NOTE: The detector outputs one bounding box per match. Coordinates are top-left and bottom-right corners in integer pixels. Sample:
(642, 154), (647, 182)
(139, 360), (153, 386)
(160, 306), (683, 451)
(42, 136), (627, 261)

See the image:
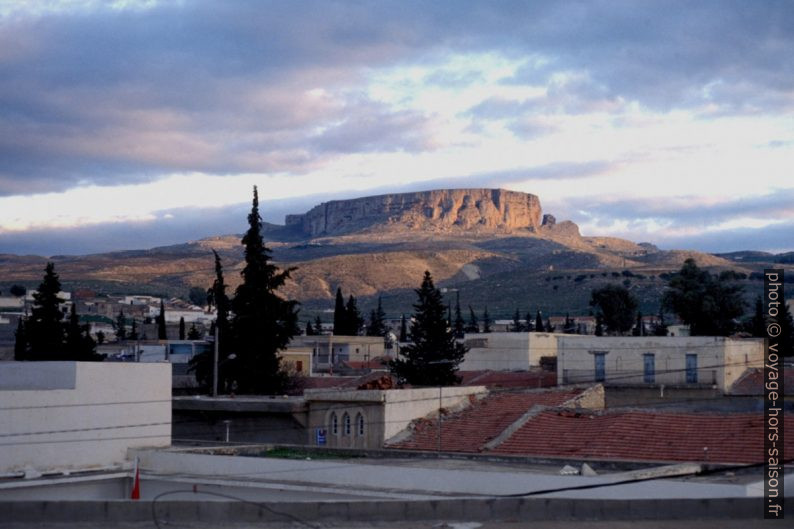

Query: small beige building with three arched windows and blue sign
(304, 386), (487, 448)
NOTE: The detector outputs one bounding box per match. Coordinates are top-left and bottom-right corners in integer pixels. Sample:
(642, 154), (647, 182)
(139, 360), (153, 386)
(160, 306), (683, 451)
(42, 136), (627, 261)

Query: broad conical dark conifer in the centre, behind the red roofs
(389, 272), (467, 386)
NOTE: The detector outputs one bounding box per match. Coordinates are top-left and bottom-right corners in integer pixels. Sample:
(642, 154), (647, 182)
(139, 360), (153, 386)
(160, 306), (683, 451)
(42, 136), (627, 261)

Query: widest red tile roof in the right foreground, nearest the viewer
(488, 410), (794, 463)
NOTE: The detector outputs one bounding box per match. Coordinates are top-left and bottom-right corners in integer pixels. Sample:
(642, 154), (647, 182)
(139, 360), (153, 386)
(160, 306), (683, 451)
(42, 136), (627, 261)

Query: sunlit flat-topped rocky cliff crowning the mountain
(286, 189), (541, 237)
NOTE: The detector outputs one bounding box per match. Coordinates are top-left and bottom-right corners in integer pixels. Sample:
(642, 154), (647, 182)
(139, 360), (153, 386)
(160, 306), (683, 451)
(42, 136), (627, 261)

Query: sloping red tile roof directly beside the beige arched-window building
(390, 389), (583, 452)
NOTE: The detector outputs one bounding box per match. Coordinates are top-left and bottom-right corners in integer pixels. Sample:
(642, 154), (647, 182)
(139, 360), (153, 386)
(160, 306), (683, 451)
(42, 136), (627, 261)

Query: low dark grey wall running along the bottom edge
(0, 498), (794, 524)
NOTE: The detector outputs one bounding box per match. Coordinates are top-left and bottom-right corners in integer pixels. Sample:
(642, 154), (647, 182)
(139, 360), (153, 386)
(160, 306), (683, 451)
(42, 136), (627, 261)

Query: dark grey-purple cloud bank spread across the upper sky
(0, 1), (794, 196)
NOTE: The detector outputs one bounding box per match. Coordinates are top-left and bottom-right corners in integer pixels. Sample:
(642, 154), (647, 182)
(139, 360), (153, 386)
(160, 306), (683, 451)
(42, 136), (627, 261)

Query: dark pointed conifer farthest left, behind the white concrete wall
(26, 263), (65, 360)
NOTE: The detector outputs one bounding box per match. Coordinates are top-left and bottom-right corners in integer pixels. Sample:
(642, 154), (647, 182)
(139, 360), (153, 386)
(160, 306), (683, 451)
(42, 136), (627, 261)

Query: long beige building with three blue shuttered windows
(557, 335), (764, 391)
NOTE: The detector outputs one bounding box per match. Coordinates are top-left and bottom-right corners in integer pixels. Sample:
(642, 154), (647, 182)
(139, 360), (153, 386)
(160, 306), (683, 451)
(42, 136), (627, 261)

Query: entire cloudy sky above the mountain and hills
(0, 0), (794, 255)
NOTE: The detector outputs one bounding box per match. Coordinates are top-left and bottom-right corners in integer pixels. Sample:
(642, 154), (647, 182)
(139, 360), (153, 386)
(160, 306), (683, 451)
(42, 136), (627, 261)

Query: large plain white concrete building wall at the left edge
(0, 362), (171, 473)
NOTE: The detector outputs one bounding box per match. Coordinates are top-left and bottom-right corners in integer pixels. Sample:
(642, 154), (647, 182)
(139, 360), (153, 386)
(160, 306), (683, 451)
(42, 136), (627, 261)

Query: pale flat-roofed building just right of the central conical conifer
(460, 332), (559, 371)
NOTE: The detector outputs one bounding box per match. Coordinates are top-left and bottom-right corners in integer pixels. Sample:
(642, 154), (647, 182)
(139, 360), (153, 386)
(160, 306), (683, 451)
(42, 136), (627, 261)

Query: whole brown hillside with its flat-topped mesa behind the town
(0, 189), (790, 318)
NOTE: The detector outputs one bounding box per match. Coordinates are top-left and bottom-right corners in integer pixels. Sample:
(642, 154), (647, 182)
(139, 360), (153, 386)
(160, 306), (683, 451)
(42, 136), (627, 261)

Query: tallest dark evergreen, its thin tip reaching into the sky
(232, 187), (300, 394)
